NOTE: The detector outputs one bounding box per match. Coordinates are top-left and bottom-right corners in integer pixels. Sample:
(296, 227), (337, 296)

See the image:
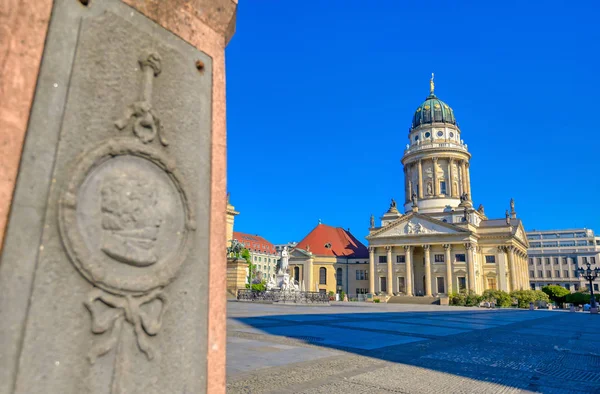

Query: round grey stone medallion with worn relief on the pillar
(59, 139), (195, 295)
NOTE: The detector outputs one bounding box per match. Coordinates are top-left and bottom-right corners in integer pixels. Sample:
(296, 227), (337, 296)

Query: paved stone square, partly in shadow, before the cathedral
(227, 301), (600, 394)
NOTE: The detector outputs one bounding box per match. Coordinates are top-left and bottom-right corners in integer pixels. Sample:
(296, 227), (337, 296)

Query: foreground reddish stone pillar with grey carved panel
(0, 0), (237, 394)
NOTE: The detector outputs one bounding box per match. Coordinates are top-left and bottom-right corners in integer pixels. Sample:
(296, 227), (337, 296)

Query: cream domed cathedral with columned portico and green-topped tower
(367, 74), (529, 302)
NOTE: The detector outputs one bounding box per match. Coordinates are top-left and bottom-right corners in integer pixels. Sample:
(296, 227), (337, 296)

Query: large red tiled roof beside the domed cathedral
(296, 224), (369, 259)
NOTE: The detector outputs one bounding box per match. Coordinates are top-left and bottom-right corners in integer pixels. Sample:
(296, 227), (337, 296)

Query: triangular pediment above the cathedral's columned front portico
(367, 213), (469, 240)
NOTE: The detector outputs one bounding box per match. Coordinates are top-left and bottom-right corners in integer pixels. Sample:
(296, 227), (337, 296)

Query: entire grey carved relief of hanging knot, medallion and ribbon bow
(59, 52), (196, 386)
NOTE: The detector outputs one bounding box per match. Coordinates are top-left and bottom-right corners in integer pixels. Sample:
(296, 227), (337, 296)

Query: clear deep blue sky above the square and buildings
(226, 0), (600, 243)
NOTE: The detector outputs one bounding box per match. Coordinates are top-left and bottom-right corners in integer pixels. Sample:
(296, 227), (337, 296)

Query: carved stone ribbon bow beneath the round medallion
(84, 289), (167, 364)
